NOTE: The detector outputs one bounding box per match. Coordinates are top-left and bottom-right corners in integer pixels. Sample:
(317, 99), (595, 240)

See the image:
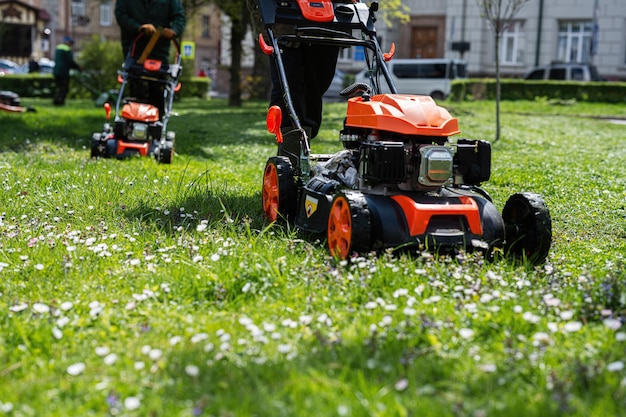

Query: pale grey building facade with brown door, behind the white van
(385, 0), (626, 80)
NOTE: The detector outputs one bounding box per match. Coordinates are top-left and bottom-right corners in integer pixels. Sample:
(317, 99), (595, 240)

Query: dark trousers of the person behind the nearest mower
(270, 44), (339, 137)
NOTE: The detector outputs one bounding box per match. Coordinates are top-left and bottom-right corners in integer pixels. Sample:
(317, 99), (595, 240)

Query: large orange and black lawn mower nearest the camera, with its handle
(258, 0), (552, 264)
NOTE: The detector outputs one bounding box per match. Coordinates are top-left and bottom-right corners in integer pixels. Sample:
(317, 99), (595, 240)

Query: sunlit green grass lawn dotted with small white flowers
(0, 99), (626, 417)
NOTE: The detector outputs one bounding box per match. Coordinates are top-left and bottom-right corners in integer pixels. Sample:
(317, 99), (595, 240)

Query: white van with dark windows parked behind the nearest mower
(356, 58), (467, 100)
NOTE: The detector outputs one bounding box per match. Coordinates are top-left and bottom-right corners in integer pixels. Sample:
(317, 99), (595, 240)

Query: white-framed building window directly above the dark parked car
(557, 20), (593, 62)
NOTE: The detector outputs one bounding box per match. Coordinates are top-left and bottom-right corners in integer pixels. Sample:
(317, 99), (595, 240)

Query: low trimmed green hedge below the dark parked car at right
(450, 78), (626, 103)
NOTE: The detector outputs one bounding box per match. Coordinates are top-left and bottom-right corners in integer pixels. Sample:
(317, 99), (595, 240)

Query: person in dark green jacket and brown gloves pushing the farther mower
(115, 0), (187, 117)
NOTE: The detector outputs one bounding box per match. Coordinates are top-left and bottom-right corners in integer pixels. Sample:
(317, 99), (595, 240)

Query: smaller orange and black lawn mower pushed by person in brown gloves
(91, 31), (183, 164)
